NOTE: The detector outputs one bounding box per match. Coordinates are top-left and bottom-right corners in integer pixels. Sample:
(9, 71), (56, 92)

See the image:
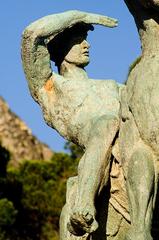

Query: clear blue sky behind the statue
(0, 0), (140, 151)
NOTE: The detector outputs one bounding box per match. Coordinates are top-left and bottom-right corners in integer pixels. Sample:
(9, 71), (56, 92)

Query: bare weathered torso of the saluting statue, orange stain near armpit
(40, 74), (120, 145)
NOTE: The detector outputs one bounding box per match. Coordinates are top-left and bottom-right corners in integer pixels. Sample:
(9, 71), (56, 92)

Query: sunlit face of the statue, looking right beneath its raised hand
(64, 36), (90, 67)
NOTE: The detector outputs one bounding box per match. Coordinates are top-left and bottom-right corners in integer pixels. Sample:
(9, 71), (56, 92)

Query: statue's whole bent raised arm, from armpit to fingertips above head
(22, 11), (117, 101)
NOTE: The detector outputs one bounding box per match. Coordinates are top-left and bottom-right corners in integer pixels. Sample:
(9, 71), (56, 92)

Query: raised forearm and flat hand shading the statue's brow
(25, 10), (117, 38)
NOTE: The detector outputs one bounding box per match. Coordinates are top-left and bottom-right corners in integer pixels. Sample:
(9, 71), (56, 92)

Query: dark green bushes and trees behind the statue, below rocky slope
(0, 143), (82, 240)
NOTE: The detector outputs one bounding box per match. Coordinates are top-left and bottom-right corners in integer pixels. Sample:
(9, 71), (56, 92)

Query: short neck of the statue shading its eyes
(60, 61), (88, 80)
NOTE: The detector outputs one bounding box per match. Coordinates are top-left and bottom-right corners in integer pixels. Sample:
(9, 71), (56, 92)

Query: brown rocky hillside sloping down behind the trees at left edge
(0, 97), (53, 166)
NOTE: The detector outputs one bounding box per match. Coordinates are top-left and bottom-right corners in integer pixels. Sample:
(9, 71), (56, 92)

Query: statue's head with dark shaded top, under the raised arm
(48, 23), (94, 71)
